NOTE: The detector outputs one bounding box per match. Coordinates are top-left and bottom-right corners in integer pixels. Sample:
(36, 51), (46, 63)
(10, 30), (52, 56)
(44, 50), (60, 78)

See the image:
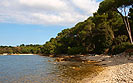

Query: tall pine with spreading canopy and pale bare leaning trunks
(98, 0), (133, 44)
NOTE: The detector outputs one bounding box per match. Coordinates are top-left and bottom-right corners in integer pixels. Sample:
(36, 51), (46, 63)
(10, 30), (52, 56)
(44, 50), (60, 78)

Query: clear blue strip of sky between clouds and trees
(0, 23), (66, 46)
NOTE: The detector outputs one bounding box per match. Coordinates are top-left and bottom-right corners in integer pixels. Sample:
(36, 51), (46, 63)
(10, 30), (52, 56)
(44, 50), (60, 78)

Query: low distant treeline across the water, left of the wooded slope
(0, 44), (42, 54)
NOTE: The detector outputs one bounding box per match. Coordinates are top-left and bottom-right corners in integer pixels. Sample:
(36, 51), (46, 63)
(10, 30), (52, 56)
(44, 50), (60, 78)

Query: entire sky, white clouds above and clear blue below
(0, 0), (102, 46)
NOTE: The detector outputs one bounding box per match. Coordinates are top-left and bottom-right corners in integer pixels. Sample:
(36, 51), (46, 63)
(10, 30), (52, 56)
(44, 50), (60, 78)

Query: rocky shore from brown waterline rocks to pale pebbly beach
(48, 53), (133, 83)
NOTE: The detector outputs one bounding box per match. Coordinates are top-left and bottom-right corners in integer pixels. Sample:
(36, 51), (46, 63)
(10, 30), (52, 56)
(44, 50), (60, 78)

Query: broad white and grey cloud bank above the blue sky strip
(0, 0), (99, 25)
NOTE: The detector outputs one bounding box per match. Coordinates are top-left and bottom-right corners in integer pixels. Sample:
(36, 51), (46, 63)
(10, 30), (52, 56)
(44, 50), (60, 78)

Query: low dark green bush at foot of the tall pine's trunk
(112, 42), (133, 54)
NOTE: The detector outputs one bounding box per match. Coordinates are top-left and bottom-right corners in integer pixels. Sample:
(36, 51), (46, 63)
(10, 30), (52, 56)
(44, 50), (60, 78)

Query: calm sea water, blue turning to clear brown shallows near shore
(0, 55), (102, 83)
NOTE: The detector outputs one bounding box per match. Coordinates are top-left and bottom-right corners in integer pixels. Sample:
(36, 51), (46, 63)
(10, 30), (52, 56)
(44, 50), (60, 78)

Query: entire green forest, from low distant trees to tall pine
(0, 0), (133, 54)
